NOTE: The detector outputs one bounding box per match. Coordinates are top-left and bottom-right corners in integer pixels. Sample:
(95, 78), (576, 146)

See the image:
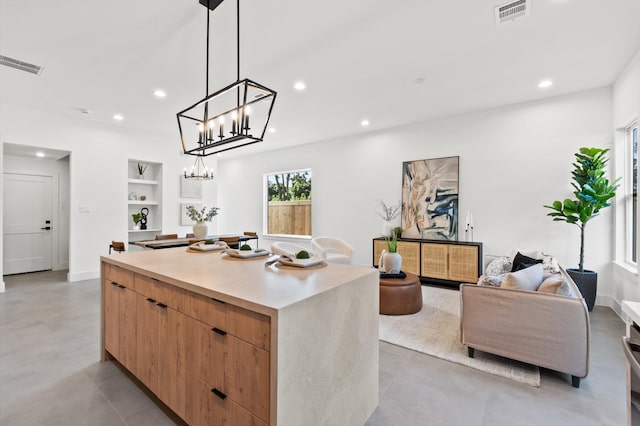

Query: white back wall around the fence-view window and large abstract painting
(218, 88), (614, 295)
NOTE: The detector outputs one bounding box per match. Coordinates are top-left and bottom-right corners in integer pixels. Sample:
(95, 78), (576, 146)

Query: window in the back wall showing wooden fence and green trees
(264, 169), (311, 237)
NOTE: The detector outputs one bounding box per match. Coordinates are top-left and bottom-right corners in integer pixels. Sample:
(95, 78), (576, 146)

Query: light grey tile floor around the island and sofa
(0, 271), (626, 426)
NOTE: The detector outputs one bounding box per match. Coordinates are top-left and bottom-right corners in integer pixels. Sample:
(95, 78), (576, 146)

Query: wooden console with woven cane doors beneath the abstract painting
(373, 237), (482, 284)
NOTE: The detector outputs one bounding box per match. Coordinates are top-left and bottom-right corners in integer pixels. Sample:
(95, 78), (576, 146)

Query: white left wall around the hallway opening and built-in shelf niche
(0, 103), (216, 281)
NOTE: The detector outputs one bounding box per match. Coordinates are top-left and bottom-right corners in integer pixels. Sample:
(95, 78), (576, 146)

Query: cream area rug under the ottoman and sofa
(379, 286), (540, 386)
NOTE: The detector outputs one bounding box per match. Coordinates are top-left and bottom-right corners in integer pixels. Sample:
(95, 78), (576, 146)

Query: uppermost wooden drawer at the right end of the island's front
(178, 291), (271, 350)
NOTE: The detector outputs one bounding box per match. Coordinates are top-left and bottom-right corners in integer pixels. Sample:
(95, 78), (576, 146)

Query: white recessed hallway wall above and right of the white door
(3, 155), (69, 270)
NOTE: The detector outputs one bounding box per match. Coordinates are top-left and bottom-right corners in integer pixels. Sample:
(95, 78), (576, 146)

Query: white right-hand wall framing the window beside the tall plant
(612, 51), (640, 314)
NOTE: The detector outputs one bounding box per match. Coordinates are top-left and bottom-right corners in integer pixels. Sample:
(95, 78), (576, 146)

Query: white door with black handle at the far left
(2, 173), (53, 275)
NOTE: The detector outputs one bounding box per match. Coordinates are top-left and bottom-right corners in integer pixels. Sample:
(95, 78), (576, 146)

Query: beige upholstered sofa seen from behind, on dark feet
(460, 269), (590, 388)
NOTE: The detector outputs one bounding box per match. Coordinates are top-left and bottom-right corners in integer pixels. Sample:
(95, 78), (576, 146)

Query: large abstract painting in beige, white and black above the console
(401, 157), (460, 241)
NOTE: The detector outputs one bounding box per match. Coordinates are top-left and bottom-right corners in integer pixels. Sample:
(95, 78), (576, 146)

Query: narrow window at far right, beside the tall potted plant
(624, 122), (638, 264)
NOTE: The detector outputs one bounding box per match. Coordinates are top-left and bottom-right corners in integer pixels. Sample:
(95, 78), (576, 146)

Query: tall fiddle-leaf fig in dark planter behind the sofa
(544, 148), (620, 311)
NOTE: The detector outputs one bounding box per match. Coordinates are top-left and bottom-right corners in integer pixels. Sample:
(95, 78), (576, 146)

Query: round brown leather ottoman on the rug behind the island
(380, 274), (422, 315)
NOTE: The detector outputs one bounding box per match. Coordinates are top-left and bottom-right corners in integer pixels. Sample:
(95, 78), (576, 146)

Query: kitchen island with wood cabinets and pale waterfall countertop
(101, 248), (379, 426)
